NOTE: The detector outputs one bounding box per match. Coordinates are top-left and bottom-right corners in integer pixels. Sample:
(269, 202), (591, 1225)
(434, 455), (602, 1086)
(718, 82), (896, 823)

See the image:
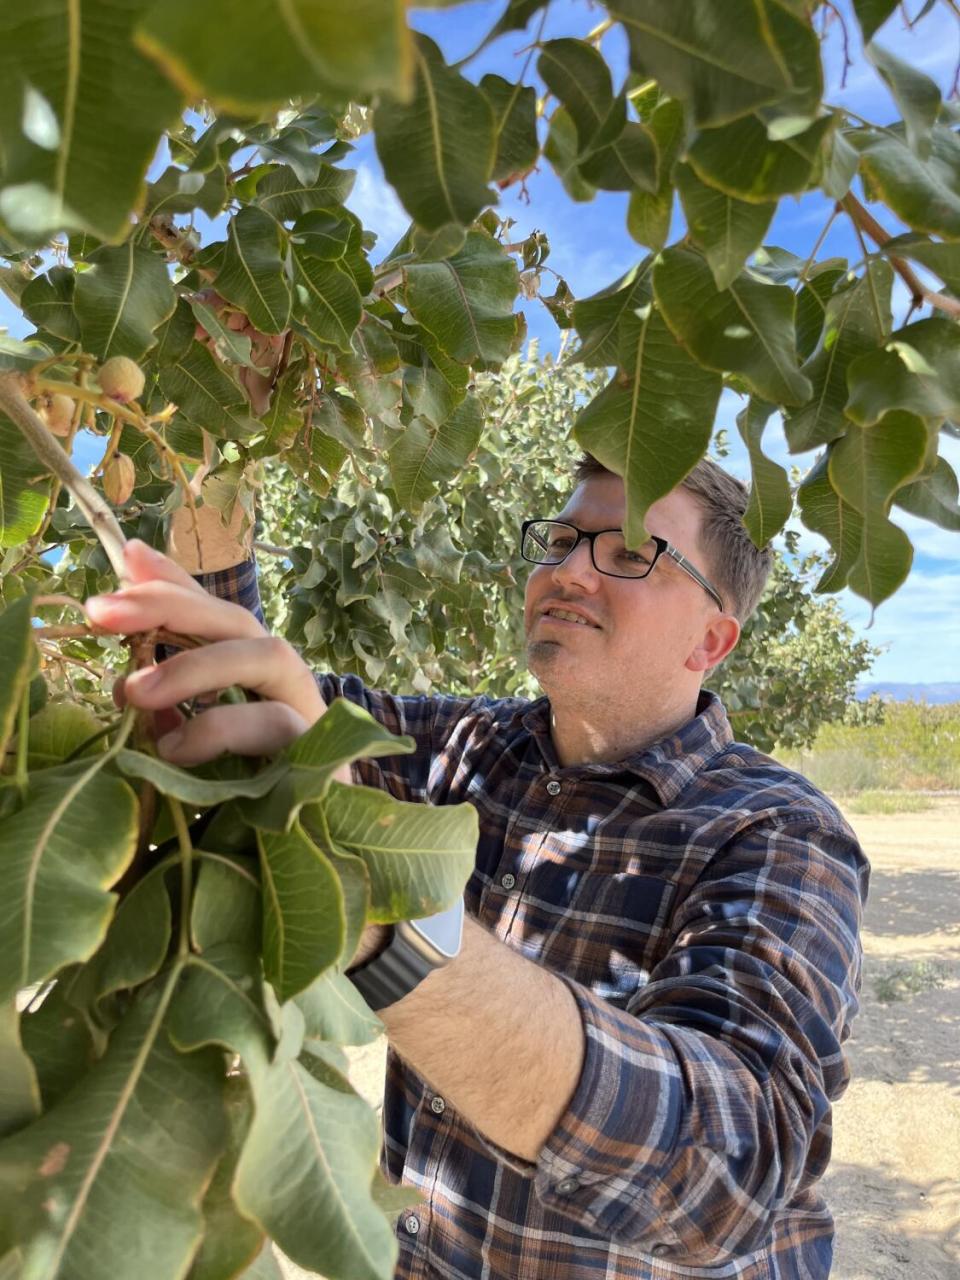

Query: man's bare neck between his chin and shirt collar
(550, 694), (699, 765)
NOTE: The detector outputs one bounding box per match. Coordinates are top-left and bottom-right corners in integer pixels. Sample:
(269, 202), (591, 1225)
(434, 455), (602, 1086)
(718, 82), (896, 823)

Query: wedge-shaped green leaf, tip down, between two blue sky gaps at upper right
(673, 164), (777, 289)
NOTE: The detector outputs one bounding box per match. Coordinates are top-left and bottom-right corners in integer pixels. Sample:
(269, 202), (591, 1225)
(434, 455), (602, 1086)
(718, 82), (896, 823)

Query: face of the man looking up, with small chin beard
(525, 475), (718, 709)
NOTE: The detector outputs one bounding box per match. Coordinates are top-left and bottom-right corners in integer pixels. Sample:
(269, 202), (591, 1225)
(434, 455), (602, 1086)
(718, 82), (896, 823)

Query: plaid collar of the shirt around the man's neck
(520, 689), (733, 805)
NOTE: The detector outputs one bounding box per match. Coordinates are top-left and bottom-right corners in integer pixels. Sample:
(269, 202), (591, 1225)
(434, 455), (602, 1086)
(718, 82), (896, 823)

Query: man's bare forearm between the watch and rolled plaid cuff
(380, 916), (584, 1161)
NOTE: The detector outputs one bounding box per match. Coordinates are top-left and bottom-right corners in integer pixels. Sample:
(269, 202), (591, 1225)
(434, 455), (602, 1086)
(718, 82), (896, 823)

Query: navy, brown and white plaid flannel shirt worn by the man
(195, 568), (868, 1280)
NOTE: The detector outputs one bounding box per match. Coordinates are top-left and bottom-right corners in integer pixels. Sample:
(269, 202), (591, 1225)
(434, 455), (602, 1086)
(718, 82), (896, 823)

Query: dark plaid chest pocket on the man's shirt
(555, 872), (675, 1007)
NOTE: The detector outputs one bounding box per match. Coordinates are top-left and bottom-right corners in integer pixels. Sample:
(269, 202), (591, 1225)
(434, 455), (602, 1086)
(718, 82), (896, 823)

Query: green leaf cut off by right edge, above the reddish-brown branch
(846, 124), (960, 239)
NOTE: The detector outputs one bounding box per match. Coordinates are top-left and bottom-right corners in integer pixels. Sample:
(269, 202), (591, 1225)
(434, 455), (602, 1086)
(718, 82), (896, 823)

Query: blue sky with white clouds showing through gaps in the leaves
(0, 0), (960, 681)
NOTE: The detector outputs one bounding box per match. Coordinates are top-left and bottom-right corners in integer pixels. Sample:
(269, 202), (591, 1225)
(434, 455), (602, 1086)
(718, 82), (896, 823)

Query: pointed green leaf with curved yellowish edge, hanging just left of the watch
(259, 824), (346, 1001)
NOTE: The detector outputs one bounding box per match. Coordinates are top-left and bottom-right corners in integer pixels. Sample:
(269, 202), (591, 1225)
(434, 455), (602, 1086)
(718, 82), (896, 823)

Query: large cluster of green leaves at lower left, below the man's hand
(0, 595), (477, 1280)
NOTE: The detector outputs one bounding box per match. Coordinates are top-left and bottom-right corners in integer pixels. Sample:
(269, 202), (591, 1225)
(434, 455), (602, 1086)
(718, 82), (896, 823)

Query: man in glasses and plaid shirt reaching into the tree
(87, 460), (867, 1280)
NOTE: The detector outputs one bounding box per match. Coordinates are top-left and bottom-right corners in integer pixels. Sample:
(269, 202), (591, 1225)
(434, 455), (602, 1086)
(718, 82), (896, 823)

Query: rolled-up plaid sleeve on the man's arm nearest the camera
(525, 814), (867, 1266)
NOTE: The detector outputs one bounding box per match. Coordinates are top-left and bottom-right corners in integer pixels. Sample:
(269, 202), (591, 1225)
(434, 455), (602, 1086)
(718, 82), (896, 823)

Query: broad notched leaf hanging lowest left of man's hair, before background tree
(387, 396), (483, 512)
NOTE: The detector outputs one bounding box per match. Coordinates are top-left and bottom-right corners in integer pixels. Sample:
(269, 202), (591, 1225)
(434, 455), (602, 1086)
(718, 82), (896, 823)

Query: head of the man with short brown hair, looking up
(525, 456), (772, 742)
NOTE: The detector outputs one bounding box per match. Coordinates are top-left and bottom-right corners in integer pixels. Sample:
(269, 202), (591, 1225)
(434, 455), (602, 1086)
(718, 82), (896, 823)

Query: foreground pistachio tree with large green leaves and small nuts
(0, 0), (960, 1280)
